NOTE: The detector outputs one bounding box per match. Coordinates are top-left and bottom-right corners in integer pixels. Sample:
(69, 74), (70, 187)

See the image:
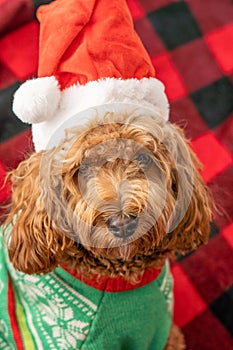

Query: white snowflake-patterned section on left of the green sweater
(10, 267), (97, 350)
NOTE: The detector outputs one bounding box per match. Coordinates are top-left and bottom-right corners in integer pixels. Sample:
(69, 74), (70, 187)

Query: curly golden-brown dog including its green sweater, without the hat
(0, 113), (211, 350)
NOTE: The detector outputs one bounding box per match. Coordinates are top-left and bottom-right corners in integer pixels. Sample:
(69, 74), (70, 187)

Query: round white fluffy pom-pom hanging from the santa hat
(12, 76), (61, 124)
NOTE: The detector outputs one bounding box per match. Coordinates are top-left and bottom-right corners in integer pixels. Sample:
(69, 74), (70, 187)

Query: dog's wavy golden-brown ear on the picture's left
(4, 152), (75, 274)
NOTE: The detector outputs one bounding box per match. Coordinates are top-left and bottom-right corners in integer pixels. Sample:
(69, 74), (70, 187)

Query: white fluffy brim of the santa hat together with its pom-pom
(13, 77), (169, 152)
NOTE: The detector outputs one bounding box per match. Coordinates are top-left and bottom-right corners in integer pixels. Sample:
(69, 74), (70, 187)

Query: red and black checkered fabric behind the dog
(0, 0), (233, 350)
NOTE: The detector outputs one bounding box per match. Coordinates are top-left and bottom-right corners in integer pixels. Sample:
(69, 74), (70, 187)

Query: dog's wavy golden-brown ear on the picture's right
(163, 125), (212, 253)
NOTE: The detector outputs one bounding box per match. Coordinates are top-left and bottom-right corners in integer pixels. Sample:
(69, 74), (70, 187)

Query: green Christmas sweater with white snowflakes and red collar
(0, 226), (173, 350)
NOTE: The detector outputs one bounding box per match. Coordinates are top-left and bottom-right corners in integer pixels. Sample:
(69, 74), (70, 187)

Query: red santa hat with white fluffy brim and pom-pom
(13, 0), (169, 151)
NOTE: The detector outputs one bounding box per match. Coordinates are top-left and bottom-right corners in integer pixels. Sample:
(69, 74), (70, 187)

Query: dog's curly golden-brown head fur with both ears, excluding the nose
(2, 116), (211, 282)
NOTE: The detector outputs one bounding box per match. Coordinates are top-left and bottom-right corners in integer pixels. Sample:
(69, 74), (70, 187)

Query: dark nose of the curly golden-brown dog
(107, 215), (138, 238)
